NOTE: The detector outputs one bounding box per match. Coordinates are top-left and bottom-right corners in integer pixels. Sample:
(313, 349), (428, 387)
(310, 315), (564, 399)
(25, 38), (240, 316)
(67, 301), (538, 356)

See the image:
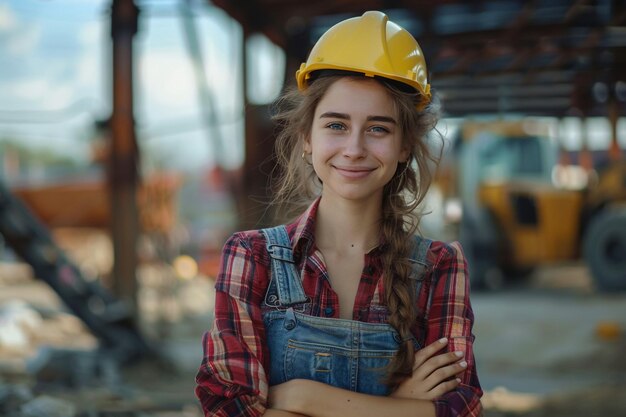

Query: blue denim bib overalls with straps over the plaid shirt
(262, 226), (431, 395)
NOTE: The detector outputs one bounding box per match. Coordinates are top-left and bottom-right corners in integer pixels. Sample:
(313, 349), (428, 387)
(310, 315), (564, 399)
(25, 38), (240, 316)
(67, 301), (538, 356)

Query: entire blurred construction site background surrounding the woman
(0, 0), (626, 417)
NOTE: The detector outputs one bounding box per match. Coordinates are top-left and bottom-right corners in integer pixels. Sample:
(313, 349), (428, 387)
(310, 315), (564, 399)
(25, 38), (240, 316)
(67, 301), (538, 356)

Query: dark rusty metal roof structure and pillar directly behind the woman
(209, 0), (626, 227)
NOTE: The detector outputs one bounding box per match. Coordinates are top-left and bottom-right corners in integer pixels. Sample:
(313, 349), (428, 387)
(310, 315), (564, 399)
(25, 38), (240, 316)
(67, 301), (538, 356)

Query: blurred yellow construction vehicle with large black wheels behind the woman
(444, 121), (626, 291)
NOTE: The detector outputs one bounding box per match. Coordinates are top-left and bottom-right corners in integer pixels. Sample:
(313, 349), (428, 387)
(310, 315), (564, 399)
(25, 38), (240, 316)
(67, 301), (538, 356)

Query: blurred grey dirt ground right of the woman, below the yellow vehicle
(472, 264), (626, 417)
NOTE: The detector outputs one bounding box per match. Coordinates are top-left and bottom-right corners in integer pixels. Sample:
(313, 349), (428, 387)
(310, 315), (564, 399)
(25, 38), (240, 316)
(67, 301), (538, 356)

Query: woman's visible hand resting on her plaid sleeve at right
(390, 338), (467, 401)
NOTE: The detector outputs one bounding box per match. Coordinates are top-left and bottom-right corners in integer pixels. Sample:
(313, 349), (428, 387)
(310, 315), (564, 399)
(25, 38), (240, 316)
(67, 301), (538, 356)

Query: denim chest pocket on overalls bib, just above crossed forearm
(283, 339), (396, 395)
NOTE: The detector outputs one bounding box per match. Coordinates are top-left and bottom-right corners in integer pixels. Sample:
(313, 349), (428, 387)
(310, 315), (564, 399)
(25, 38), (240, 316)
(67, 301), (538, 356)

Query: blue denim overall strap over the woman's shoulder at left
(261, 226), (307, 306)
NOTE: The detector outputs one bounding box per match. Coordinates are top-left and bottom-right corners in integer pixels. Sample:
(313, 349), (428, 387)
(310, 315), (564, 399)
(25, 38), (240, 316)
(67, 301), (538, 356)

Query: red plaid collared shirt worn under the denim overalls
(196, 199), (482, 417)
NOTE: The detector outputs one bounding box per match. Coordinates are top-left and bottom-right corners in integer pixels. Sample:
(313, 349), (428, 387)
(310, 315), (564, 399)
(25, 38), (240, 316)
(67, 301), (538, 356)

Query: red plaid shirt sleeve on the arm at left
(195, 234), (268, 417)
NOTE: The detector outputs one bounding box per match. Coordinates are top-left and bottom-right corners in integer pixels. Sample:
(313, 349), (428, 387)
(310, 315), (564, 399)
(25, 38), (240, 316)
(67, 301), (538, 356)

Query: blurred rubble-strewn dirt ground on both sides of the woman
(0, 258), (626, 417)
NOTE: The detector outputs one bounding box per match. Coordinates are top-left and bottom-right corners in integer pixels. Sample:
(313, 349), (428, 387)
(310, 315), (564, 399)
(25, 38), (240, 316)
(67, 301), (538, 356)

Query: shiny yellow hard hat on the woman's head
(296, 11), (431, 109)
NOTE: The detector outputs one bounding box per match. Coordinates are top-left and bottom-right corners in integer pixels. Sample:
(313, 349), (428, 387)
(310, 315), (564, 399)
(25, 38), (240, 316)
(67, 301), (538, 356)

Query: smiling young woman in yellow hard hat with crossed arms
(196, 12), (482, 417)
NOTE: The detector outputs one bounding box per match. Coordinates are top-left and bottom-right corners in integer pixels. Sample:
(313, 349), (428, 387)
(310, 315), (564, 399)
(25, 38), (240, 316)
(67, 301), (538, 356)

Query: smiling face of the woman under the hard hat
(304, 77), (409, 205)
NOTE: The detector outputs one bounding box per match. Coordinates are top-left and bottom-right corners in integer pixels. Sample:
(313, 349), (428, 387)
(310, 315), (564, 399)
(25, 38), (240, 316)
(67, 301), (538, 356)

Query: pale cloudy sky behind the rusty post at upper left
(0, 0), (284, 174)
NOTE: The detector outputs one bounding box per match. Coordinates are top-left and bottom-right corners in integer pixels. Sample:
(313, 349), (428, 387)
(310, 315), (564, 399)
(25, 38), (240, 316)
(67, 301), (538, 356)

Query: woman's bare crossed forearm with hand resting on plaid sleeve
(264, 339), (467, 417)
